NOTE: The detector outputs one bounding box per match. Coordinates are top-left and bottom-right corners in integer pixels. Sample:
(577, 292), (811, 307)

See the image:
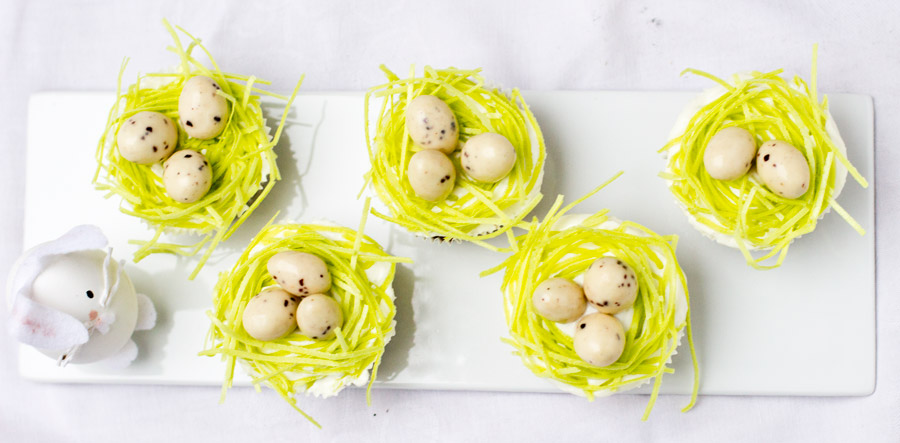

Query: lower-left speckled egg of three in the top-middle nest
(406, 149), (456, 202)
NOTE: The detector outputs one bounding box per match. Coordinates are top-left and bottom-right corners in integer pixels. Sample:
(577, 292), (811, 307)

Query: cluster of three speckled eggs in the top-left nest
(116, 76), (228, 203)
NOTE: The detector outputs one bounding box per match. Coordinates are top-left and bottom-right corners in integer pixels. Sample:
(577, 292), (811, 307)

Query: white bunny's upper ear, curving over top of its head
(7, 225), (108, 306)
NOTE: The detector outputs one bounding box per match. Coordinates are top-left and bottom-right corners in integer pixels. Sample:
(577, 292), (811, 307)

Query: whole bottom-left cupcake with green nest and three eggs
(200, 223), (406, 426)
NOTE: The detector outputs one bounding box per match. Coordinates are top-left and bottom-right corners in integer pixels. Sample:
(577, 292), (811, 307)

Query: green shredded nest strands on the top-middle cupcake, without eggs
(365, 66), (546, 250)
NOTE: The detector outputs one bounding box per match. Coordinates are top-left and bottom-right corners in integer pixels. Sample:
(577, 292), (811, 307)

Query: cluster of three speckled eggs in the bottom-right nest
(532, 257), (638, 367)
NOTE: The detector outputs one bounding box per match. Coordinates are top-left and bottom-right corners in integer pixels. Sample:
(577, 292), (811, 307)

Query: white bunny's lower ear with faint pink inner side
(9, 297), (90, 350)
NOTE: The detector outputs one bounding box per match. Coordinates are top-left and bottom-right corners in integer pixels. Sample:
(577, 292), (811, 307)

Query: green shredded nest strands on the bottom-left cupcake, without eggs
(200, 224), (409, 426)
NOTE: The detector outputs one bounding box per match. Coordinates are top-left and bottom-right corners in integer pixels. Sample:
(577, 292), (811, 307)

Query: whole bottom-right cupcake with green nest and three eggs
(485, 175), (699, 420)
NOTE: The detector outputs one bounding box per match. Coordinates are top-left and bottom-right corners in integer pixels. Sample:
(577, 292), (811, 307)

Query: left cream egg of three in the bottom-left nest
(241, 288), (300, 341)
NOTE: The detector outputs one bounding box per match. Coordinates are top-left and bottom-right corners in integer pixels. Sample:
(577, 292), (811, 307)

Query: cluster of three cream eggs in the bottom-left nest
(241, 251), (344, 341)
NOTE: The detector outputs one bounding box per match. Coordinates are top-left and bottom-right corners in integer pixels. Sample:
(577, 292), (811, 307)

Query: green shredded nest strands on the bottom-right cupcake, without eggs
(482, 173), (699, 420)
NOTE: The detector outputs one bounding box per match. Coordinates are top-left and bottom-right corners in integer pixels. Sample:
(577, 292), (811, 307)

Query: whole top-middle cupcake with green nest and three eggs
(365, 66), (546, 249)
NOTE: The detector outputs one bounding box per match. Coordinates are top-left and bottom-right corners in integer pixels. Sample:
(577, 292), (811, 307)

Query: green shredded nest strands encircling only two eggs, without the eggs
(660, 49), (868, 269)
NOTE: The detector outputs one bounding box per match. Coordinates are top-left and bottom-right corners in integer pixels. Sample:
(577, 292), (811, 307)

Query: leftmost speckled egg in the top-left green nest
(116, 111), (178, 165)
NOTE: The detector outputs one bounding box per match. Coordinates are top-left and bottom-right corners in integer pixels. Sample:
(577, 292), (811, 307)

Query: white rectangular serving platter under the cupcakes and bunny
(19, 91), (875, 395)
